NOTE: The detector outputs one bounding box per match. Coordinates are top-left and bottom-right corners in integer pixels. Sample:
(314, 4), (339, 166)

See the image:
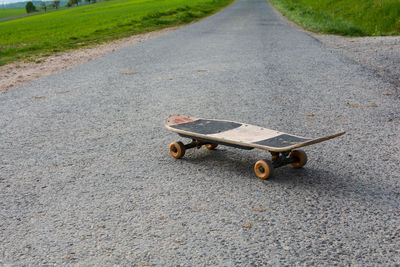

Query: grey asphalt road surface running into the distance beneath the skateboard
(0, 0), (400, 266)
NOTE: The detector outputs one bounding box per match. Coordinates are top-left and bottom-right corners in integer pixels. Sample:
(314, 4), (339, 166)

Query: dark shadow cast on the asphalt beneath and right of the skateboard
(182, 149), (399, 206)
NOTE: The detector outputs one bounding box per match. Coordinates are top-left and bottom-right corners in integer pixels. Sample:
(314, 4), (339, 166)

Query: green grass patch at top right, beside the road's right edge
(269, 0), (400, 36)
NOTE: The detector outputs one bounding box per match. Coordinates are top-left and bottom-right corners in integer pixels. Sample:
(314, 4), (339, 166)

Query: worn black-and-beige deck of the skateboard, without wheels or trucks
(165, 115), (344, 152)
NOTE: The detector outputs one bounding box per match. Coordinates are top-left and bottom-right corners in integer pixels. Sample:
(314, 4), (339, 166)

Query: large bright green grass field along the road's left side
(0, 0), (232, 65)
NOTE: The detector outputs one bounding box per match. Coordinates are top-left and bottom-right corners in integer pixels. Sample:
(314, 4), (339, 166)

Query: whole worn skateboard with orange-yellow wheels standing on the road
(165, 115), (345, 179)
